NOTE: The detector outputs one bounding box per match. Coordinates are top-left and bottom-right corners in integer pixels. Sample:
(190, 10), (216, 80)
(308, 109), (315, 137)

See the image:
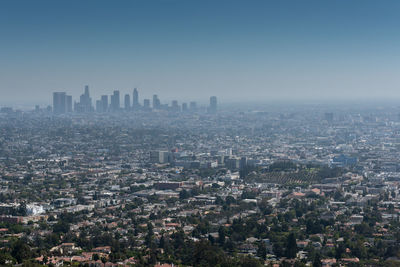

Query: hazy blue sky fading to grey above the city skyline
(0, 0), (400, 107)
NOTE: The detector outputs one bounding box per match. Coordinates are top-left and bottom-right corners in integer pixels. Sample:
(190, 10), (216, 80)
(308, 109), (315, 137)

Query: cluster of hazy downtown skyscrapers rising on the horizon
(53, 85), (217, 114)
